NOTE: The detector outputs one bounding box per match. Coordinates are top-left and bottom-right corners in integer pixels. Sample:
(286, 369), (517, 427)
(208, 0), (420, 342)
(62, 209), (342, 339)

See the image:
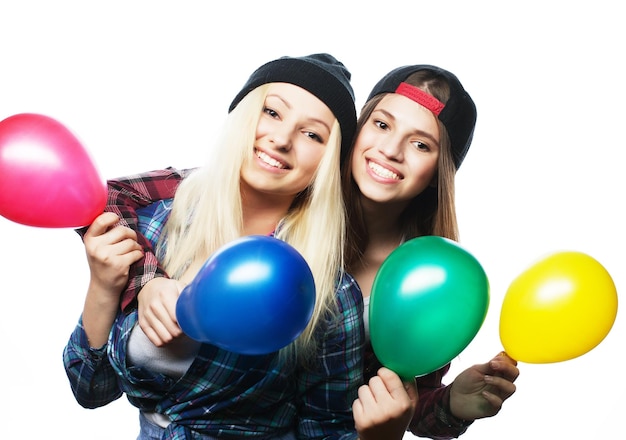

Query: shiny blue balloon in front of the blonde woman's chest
(176, 235), (315, 355)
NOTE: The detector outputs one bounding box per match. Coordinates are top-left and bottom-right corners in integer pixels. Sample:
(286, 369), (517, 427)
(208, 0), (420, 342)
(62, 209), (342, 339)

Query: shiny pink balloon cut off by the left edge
(0, 113), (107, 228)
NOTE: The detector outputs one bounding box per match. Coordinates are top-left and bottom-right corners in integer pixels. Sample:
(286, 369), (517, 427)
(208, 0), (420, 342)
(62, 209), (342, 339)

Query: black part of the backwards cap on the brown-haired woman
(367, 64), (476, 169)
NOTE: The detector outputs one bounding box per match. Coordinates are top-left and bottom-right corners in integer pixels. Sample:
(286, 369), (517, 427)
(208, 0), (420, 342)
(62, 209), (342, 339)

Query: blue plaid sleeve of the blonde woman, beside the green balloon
(298, 274), (365, 439)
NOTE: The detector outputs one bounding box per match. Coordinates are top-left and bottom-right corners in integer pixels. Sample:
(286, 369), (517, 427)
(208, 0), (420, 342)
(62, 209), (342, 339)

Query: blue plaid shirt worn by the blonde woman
(63, 200), (364, 439)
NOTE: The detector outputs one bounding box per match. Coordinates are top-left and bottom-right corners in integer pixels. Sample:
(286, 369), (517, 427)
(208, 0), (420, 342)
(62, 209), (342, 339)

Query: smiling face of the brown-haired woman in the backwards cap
(352, 93), (439, 204)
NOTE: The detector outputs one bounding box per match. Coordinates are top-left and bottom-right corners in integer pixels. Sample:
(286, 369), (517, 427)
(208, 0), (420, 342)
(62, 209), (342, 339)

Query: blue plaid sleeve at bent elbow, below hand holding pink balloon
(63, 318), (122, 408)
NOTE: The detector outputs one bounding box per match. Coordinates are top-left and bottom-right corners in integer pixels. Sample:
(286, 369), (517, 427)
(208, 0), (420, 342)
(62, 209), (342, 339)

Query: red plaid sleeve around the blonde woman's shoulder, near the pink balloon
(78, 167), (192, 310)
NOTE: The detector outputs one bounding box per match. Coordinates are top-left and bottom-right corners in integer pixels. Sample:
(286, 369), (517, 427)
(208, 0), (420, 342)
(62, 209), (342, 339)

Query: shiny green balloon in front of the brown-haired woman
(369, 236), (489, 378)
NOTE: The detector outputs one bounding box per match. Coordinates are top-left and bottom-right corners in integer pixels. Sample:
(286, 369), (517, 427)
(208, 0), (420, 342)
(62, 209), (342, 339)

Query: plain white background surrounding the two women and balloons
(0, 0), (626, 440)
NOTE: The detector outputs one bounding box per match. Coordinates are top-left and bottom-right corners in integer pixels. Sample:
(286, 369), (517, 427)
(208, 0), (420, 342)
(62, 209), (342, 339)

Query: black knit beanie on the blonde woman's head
(228, 53), (356, 162)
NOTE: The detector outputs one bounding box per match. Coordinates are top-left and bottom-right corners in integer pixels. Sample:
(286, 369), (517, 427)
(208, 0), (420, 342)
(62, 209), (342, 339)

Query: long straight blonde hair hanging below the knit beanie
(159, 84), (346, 360)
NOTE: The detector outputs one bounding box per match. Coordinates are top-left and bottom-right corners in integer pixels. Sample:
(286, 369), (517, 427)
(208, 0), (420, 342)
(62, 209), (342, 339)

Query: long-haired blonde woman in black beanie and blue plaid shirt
(64, 54), (363, 439)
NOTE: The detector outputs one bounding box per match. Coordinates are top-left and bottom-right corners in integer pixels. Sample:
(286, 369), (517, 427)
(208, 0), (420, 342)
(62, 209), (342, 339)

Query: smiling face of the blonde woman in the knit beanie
(241, 83), (335, 196)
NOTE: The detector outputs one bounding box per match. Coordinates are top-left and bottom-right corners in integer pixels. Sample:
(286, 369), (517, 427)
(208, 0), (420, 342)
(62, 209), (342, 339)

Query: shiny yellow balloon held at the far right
(500, 252), (617, 364)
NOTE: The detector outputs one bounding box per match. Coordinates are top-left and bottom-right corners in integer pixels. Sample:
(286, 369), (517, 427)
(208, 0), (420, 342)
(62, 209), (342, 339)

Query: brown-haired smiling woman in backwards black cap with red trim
(342, 65), (519, 439)
